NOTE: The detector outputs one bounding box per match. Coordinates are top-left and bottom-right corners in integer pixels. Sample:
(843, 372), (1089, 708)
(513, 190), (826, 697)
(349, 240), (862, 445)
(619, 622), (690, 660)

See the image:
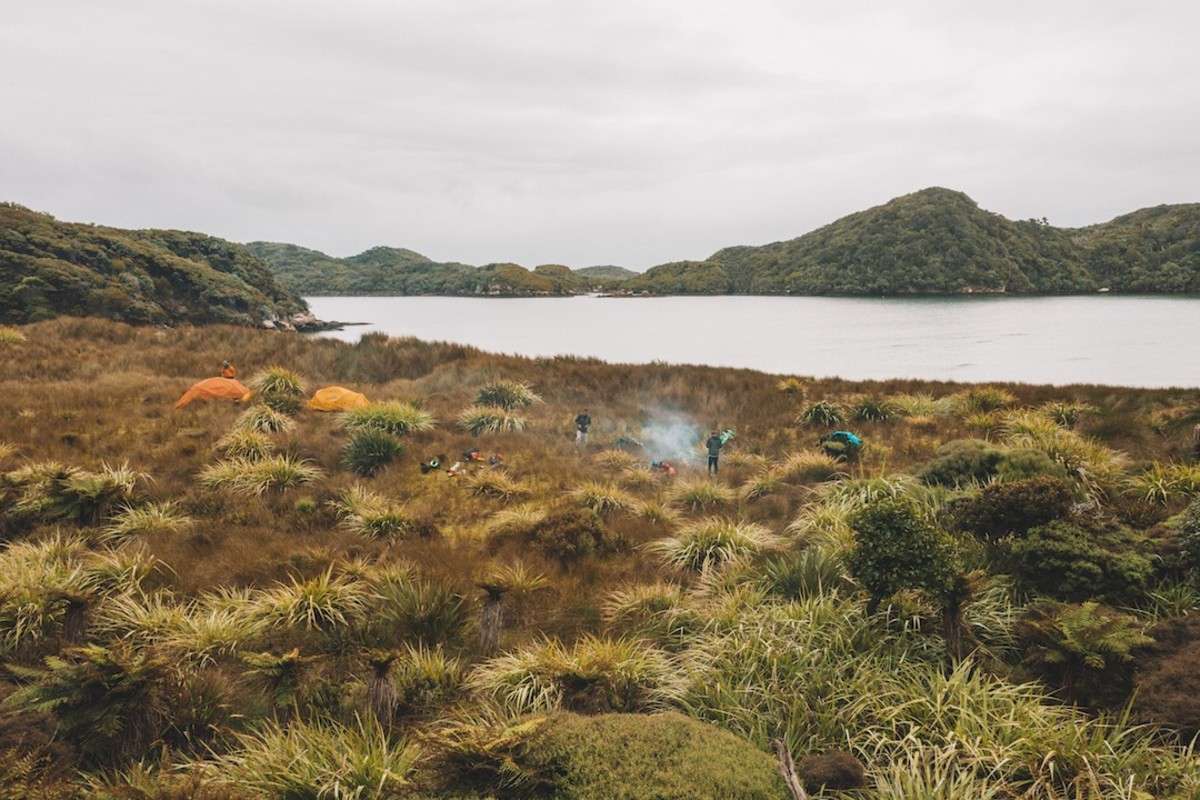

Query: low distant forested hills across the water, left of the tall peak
(246, 241), (636, 296)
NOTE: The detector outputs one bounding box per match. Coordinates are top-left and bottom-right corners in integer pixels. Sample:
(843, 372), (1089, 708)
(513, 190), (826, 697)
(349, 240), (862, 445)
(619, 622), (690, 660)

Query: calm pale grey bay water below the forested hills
(307, 295), (1200, 387)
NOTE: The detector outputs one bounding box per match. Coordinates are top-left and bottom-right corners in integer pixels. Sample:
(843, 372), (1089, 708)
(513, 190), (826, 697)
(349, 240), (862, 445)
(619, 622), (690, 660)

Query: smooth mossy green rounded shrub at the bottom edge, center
(517, 712), (787, 800)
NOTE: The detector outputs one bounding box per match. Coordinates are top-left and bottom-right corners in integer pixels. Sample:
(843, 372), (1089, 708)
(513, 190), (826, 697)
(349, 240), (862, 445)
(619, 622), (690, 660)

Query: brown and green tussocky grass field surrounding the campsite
(0, 319), (1200, 800)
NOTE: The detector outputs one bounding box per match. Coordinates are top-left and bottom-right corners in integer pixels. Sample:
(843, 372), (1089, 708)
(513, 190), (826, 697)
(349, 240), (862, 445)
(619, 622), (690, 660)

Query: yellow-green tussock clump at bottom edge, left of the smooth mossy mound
(190, 720), (420, 800)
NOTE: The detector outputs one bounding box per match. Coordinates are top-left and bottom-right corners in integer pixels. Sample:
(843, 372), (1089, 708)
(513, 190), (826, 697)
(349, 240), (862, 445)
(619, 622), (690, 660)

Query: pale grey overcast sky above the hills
(0, 0), (1200, 270)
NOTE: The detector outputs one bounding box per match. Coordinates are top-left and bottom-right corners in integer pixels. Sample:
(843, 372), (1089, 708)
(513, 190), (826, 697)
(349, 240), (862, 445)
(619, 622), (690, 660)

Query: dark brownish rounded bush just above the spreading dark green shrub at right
(950, 477), (1074, 541)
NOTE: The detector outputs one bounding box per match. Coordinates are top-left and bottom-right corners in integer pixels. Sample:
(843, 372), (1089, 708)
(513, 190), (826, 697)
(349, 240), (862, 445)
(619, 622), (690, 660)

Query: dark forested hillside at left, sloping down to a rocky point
(0, 203), (313, 329)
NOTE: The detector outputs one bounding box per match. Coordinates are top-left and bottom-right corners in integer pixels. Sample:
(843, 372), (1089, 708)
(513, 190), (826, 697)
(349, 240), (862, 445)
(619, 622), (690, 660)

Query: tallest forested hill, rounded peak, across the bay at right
(622, 188), (1200, 295)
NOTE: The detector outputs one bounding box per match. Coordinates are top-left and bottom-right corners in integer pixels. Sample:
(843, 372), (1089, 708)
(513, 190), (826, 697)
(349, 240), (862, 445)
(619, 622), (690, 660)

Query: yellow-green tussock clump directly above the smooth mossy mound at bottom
(467, 636), (686, 715)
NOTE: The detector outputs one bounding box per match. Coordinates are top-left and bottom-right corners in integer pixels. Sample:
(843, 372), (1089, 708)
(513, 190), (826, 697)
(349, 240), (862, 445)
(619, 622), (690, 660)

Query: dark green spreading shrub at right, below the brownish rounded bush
(1000, 519), (1154, 607)
